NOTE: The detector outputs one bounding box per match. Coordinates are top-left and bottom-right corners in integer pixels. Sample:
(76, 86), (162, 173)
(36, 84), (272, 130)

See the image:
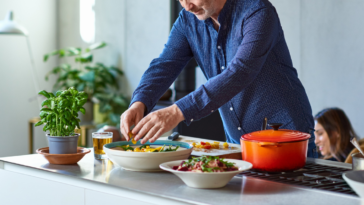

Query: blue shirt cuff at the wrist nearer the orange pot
(175, 94), (199, 126)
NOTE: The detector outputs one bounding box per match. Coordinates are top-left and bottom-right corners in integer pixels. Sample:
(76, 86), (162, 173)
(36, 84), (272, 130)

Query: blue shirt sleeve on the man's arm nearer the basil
(131, 14), (193, 114)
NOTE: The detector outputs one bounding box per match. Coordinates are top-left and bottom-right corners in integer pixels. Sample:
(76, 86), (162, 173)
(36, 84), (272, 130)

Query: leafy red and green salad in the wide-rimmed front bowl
(173, 156), (239, 172)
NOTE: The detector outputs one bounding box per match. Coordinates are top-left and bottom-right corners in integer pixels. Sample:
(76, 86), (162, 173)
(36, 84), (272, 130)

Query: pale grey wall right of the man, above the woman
(271, 0), (364, 137)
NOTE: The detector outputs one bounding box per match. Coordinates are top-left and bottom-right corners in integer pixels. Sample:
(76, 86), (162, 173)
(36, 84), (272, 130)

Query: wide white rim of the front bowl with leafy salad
(159, 158), (253, 175)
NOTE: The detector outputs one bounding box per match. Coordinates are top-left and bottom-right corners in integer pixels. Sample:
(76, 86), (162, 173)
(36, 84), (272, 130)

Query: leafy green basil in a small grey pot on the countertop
(35, 87), (87, 154)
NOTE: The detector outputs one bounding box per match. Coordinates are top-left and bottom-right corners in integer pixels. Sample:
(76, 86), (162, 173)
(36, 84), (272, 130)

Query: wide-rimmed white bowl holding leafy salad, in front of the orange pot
(159, 159), (253, 189)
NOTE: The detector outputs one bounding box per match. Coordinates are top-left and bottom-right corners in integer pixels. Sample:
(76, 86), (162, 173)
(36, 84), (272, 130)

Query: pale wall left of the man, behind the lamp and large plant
(0, 0), (170, 157)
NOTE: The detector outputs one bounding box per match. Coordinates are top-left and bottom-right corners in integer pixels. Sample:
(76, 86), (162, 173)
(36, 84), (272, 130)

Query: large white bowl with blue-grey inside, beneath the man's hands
(104, 140), (193, 171)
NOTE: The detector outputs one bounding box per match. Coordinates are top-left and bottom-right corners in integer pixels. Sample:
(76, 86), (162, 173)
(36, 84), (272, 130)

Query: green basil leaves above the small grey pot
(35, 87), (88, 136)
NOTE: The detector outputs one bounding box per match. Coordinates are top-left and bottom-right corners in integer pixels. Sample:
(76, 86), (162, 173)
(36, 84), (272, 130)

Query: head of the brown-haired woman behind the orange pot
(315, 108), (358, 162)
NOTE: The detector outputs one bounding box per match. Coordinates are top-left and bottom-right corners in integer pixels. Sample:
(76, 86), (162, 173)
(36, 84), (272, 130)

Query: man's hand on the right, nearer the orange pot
(132, 104), (185, 144)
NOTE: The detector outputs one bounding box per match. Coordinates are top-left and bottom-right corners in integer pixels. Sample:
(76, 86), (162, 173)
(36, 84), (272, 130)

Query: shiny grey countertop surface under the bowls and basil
(0, 150), (360, 205)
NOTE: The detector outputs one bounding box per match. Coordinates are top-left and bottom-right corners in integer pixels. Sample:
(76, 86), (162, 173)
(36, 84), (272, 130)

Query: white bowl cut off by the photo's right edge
(343, 170), (364, 199)
